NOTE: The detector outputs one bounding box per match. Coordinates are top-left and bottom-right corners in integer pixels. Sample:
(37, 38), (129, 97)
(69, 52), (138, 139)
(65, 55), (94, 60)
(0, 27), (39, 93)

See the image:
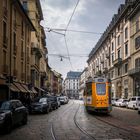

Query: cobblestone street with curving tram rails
(0, 100), (140, 140)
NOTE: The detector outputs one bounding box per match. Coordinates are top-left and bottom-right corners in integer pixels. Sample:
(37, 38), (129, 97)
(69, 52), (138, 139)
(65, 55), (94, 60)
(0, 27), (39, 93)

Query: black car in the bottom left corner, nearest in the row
(0, 100), (28, 133)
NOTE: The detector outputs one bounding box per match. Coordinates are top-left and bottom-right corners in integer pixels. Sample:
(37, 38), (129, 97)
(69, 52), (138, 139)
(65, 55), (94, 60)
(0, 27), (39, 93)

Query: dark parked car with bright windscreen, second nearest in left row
(29, 97), (51, 113)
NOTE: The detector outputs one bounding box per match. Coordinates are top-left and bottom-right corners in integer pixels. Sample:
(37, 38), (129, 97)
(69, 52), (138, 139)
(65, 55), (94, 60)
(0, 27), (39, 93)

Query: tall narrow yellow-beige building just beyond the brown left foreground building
(21, 0), (48, 94)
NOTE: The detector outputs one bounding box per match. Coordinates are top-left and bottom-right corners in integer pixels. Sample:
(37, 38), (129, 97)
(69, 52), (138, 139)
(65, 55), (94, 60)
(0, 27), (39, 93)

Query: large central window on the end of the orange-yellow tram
(96, 84), (106, 95)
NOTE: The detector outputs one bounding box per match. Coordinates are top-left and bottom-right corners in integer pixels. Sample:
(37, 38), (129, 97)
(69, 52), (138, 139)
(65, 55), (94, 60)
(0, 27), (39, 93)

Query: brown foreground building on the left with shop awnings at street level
(0, 0), (35, 100)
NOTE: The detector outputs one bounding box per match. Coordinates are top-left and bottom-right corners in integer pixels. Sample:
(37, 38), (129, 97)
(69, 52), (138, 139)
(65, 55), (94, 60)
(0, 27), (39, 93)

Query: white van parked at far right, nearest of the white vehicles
(127, 96), (140, 109)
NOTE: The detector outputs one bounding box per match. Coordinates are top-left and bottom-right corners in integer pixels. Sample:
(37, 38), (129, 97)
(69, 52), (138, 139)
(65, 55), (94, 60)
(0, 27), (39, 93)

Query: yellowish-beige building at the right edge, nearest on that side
(128, 3), (140, 96)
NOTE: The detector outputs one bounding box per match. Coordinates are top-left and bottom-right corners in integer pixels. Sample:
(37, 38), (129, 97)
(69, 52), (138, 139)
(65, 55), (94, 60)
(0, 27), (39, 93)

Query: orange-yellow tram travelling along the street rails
(84, 77), (112, 113)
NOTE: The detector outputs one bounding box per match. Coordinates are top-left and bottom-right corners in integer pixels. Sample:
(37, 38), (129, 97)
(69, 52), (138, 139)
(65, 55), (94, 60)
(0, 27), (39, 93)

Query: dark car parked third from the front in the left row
(46, 95), (59, 109)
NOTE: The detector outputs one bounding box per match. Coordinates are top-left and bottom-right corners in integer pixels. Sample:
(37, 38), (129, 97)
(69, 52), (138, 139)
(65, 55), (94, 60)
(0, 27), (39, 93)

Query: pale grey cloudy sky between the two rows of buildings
(40, 0), (124, 78)
